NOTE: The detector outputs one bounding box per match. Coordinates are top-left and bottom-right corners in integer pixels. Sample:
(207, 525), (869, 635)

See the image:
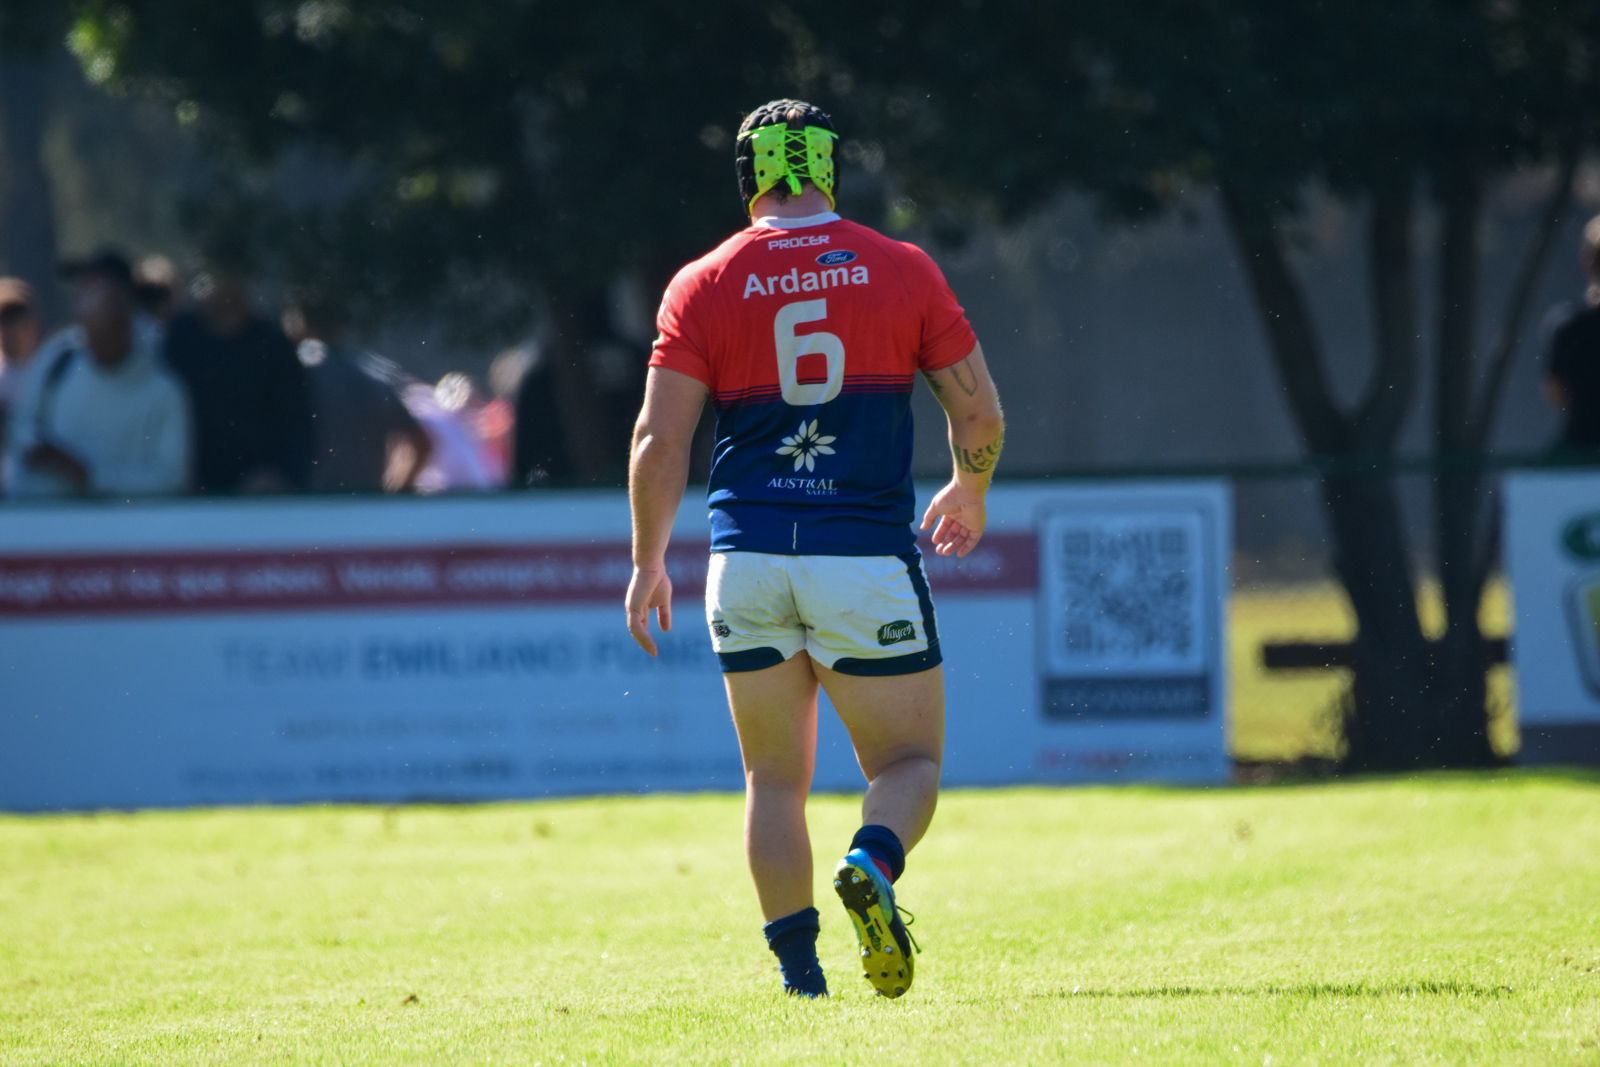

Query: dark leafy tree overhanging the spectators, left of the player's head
(72, 0), (812, 482)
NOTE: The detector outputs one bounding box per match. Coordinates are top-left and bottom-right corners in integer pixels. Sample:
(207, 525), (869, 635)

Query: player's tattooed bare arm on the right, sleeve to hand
(922, 344), (1005, 557)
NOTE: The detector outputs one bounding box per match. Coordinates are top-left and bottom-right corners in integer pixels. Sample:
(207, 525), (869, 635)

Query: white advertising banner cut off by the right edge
(1506, 470), (1600, 765)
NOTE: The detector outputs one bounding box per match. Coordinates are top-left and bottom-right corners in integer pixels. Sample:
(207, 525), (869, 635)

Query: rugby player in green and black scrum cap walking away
(627, 99), (1003, 997)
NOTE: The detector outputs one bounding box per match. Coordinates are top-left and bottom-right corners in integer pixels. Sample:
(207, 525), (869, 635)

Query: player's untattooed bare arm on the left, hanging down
(627, 366), (709, 656)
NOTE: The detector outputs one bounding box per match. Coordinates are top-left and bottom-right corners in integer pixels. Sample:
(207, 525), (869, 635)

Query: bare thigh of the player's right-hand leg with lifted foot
(812, 656), (944, 782)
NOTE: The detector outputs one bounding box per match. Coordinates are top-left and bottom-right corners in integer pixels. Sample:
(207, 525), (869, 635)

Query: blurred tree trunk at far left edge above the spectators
(0, 56), (64, 322)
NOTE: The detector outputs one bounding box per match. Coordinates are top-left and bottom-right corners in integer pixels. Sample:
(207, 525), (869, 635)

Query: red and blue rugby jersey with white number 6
(650, 214), (978, 555)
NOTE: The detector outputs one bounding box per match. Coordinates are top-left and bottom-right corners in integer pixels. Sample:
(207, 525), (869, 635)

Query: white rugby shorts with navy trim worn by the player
(706, 552), (941, 675)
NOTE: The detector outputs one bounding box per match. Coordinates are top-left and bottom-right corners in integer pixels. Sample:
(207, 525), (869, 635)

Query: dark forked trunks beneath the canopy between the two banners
(1222, 176), (1490, 771)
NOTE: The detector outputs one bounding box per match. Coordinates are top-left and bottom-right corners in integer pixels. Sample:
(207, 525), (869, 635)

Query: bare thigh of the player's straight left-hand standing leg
(723, 651), (832, 790)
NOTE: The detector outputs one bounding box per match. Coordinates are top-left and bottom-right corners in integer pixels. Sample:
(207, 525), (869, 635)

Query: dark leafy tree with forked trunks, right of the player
(812, 0), (1600, 769)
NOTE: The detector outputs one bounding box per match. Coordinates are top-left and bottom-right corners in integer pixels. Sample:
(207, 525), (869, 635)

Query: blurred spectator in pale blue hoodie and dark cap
(6, 253), (190, 496)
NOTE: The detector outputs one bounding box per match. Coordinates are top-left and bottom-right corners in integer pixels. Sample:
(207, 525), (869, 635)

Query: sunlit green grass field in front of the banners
(0, 773), (1600, 1067)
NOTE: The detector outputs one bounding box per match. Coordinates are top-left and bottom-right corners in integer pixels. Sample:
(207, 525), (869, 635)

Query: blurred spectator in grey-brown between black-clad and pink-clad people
(283, 293), (434, 493)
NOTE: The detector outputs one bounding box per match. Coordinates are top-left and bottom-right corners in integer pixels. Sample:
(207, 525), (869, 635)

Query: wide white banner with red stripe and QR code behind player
(0, 483), (1229, 809)
